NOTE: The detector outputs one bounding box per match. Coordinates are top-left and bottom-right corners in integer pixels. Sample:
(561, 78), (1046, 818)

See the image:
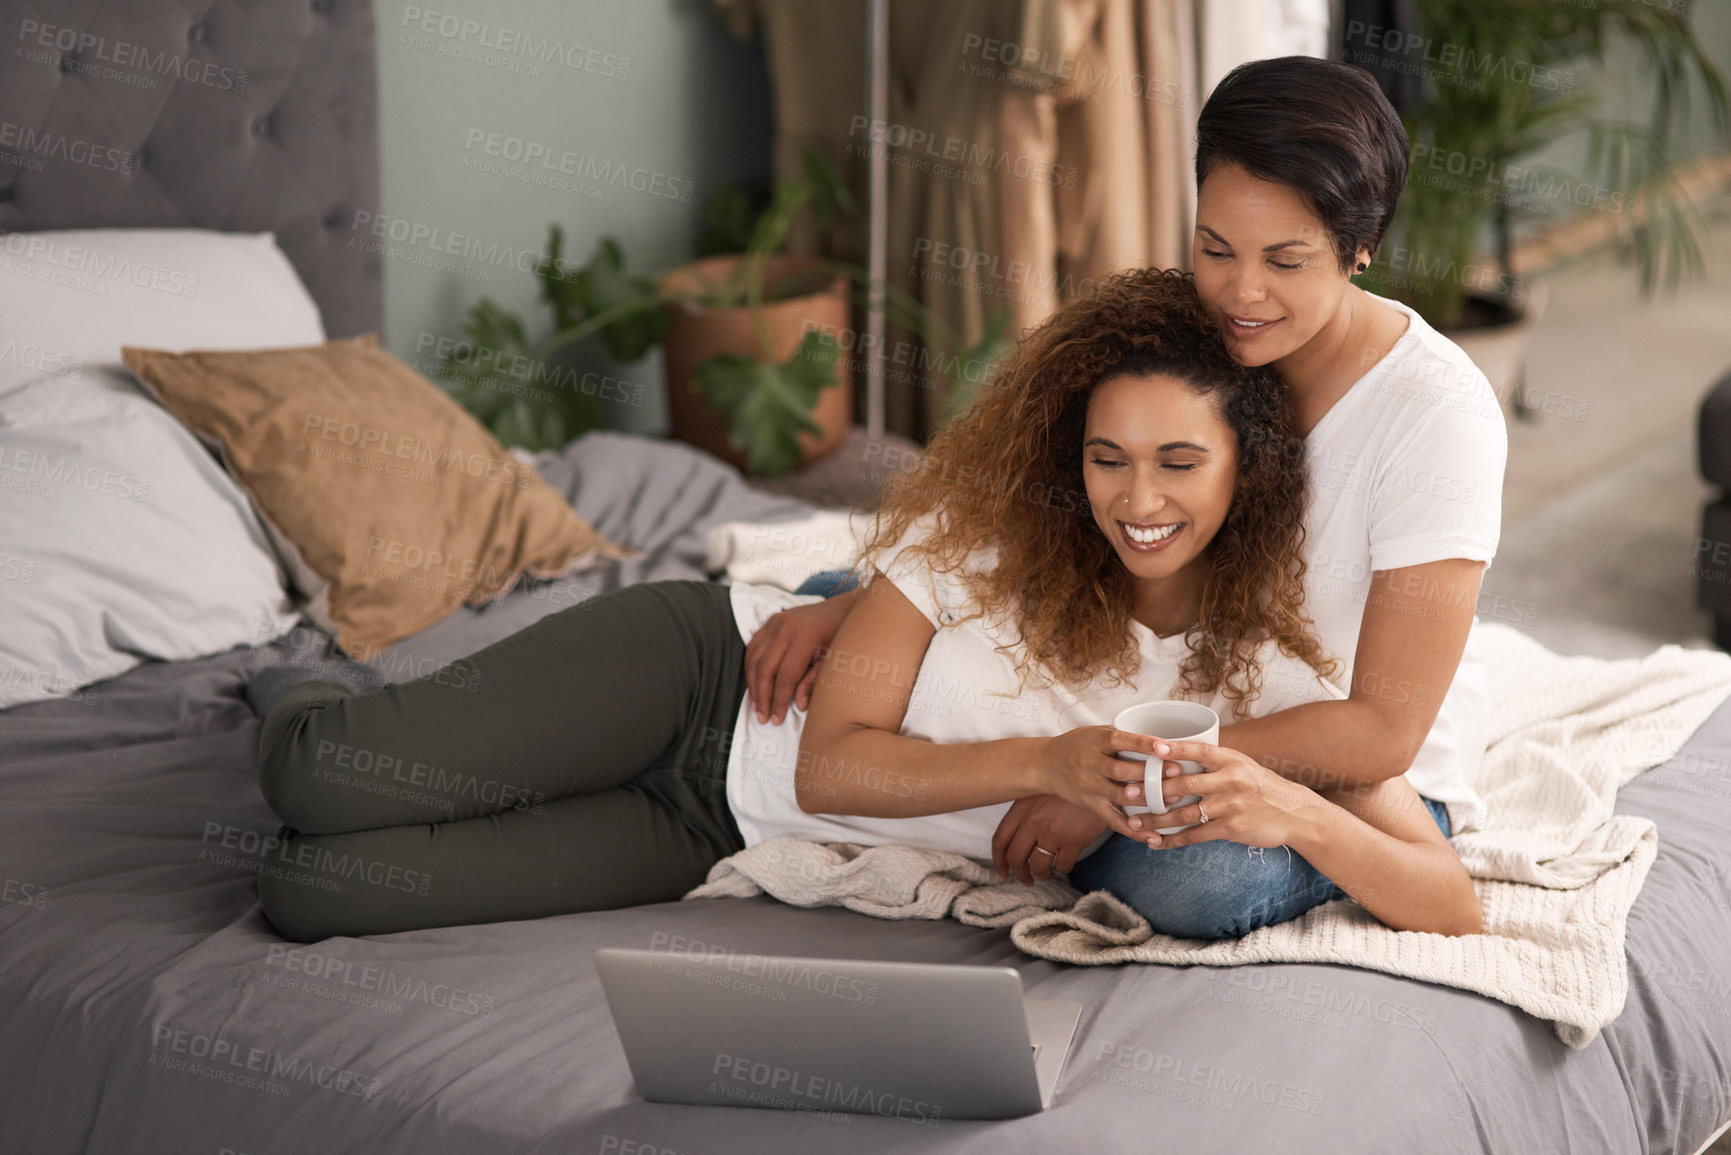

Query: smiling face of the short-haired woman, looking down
(1191, 165), (1371, 365)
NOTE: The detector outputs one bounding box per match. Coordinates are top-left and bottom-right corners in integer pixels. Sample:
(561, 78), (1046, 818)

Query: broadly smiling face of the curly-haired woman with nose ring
(1082, 374), (1238, 632)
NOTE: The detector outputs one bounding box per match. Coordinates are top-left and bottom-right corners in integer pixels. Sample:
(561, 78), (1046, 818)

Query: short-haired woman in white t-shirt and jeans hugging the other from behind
(746, 57), (1508, 933)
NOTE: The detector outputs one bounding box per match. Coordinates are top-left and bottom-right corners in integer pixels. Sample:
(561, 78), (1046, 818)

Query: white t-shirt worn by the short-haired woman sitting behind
(1305, 290), (1508, 831)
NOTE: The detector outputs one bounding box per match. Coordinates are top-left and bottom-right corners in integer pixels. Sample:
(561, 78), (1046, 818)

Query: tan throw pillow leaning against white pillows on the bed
(121, 334), (632, 658)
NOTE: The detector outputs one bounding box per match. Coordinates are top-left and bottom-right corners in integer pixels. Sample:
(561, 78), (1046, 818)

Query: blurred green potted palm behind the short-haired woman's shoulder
(1362, 0), (1728, 410)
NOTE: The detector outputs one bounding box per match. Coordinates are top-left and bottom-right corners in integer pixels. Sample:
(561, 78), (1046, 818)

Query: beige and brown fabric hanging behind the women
(715, 0), (1200, 438)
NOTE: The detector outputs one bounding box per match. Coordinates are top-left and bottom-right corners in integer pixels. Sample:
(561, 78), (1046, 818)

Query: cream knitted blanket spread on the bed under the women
(685, 623), (1731, 1048)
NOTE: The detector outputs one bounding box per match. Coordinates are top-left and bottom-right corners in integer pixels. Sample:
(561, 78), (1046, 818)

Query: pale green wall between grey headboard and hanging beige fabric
(377, 0), (772, 431)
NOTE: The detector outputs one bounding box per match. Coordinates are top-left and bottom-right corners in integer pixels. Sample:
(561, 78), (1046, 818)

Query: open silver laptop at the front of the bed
(595, 947), (1082, 1126)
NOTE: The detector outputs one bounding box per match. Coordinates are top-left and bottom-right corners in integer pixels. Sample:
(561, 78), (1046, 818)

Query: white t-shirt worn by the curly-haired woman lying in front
(727, 521), (1345, 861)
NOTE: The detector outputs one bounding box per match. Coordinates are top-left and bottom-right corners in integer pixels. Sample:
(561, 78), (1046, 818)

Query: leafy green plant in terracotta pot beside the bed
(440, 151), (1007, 476)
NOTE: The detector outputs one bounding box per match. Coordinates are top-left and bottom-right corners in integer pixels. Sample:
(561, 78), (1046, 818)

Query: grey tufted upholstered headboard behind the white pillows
(0, 0), (384, 338)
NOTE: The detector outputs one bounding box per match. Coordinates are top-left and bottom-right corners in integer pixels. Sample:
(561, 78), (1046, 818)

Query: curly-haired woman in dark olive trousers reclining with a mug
(254, 272), (1478, 940)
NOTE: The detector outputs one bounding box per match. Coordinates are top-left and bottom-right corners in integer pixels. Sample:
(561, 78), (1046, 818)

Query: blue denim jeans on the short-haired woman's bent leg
(1070, 798), (1449, 939)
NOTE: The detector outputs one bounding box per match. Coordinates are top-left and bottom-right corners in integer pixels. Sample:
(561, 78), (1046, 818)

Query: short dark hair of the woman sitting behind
(1196, 55), (1407, 268)
